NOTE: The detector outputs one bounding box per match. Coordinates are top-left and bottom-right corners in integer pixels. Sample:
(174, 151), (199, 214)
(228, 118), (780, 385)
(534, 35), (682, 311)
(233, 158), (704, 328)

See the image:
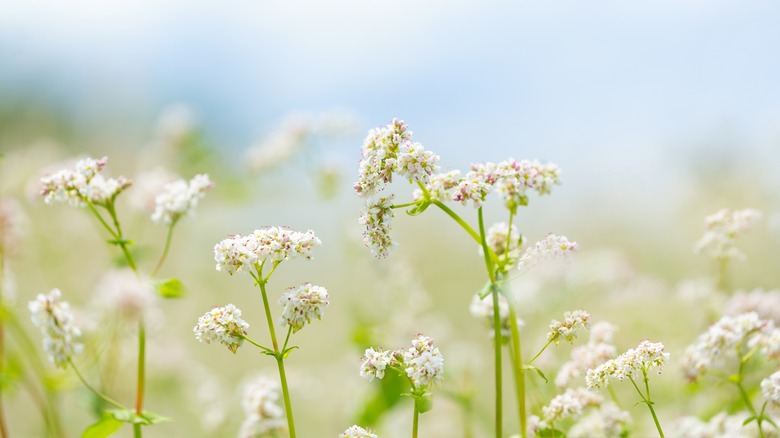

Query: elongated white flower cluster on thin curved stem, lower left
(27, 289), (84, 368)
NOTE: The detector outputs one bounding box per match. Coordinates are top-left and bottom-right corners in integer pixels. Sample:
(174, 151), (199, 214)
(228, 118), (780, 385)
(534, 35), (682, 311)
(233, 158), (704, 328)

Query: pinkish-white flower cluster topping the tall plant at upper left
(41, 157), (131, 206)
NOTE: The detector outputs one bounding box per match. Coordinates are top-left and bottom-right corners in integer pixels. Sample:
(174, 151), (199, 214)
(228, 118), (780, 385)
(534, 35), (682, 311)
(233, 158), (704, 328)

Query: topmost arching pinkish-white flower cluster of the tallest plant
(354, 119), (439, 198)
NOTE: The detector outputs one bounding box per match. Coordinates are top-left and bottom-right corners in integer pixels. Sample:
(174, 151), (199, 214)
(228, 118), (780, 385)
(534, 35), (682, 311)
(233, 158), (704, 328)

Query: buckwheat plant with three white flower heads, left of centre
(200, 227), (329, 438)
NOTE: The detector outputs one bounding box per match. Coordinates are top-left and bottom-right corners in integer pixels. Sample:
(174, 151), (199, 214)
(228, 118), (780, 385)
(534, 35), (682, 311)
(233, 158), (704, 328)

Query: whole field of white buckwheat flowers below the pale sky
(0, 108), (780, 438)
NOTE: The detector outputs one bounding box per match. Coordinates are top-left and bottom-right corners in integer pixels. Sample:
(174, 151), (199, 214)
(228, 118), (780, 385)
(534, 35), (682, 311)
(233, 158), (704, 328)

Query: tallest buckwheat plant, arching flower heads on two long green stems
(353, 119), (577, 437)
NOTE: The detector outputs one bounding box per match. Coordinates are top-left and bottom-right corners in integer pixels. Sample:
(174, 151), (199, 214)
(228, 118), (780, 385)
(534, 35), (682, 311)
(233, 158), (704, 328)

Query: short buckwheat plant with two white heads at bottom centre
(356, 334), (444, 438)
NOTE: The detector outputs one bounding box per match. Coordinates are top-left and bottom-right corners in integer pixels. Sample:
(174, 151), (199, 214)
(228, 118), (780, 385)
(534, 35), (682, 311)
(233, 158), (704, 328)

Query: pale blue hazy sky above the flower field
(0, 0), (780, 205)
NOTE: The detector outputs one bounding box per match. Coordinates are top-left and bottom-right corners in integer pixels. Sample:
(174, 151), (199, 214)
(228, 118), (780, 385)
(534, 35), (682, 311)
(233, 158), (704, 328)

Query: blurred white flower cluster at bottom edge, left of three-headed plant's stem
(239, 377), (286, 438)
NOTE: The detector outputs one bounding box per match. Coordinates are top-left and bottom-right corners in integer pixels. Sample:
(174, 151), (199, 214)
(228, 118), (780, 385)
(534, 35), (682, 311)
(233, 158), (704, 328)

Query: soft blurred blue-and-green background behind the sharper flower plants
(0, 0), (780, 437)
